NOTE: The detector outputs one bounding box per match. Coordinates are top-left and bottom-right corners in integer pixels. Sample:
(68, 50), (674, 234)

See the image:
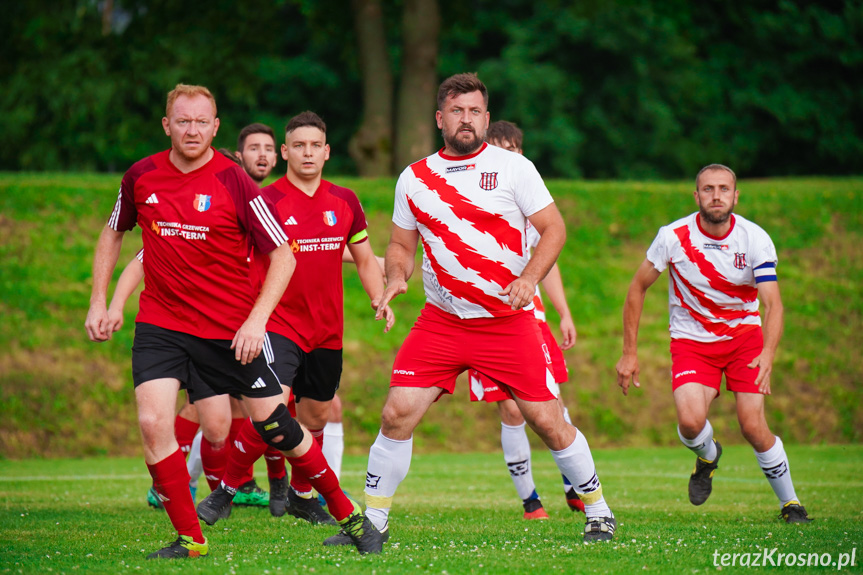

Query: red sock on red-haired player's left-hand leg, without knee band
(147, 449), (204, 543)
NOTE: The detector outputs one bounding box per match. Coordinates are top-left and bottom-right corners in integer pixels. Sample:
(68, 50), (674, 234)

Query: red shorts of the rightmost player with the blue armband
(671, 327), (764, 393)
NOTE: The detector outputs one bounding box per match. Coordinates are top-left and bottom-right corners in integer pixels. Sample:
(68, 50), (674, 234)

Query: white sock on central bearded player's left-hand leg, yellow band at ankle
(365, 433), (414, 531)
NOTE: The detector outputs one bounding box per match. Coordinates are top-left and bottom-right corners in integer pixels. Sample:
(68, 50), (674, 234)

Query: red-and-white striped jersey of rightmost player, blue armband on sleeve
(647, 212), (777, 342)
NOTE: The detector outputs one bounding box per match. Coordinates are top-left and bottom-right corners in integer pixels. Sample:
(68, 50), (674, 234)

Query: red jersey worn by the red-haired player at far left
(108, 150), (287, 339)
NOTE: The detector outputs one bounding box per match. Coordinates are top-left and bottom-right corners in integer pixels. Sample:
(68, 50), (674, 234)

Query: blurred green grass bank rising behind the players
(0, 174), (863, 457)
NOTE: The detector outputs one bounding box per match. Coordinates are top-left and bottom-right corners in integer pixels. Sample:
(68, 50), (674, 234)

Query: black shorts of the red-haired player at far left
(132, 323), (282, 400)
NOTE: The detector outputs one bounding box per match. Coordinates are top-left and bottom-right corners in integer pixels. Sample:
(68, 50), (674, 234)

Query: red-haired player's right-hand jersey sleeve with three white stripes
(219, 165), (288, 254)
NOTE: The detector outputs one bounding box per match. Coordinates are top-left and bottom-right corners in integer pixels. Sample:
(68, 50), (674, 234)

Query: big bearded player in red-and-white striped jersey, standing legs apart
(354, 74), (616, 542)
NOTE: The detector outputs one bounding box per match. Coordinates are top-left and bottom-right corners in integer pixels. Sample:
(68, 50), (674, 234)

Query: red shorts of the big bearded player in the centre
(390, 304), (557, 401)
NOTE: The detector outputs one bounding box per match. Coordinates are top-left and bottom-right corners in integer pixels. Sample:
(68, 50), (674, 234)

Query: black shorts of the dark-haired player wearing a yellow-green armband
(264, 332), (342, 403)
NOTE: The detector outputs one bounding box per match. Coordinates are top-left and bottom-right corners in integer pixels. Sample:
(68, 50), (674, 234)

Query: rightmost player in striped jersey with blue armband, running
(617, 164), (810, 523)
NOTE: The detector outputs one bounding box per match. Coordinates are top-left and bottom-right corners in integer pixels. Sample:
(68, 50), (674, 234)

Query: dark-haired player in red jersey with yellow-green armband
(198, 112), (393, 524)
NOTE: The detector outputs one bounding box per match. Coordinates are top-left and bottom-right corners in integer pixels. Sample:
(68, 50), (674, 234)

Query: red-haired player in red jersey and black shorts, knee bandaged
(85, 84), (381, 558)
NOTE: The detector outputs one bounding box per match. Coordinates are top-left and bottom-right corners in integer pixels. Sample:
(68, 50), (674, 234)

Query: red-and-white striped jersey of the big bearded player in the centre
(393, 144), (554, 319)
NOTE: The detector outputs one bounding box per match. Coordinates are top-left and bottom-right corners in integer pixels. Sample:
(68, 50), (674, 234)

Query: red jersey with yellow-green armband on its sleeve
(254, 177), (368, 352)
